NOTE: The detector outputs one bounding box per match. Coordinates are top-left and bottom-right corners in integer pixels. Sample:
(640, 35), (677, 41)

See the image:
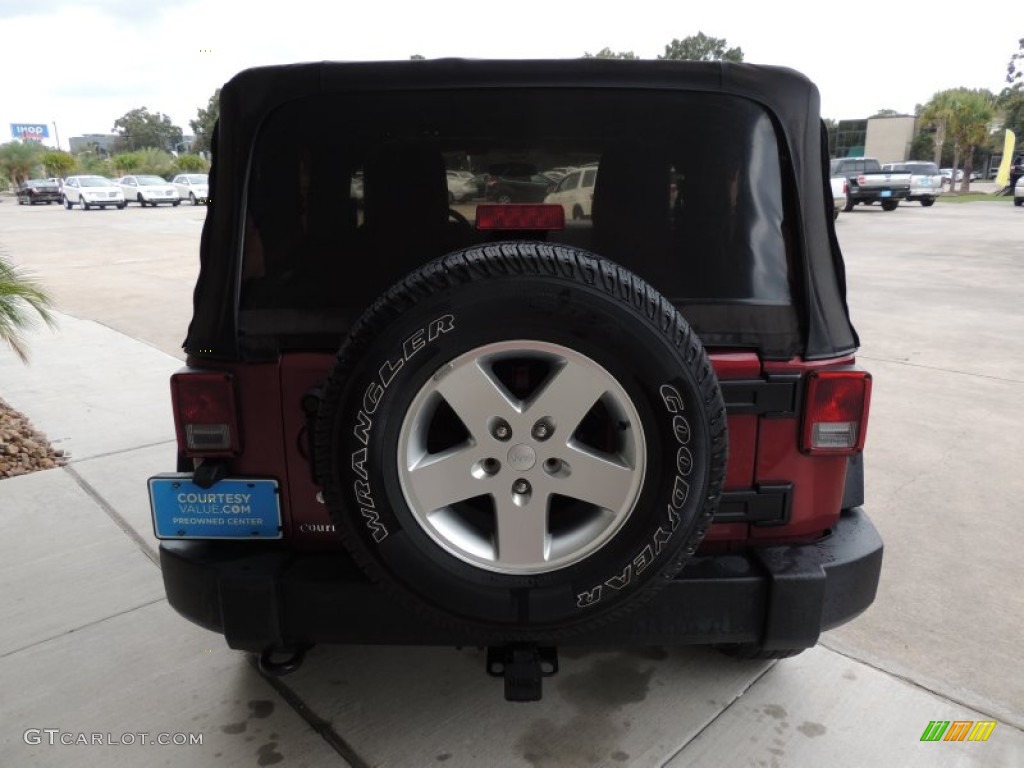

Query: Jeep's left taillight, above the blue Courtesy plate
(171, 372), (241, 456)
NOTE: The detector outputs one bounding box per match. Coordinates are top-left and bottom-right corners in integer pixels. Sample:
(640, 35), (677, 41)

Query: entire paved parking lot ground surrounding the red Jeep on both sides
(0, 199), (1024, 768)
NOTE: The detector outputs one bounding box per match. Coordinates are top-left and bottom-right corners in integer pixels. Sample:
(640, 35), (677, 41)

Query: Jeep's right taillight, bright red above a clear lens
(801, 371), (871, 456)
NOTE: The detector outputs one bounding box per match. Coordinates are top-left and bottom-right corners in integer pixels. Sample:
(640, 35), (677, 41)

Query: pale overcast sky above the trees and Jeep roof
(0, 0), (1024, 148)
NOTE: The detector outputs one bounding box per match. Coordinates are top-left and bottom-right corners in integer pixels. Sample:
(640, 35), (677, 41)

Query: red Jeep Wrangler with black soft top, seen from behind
(150, 59), (882, 699)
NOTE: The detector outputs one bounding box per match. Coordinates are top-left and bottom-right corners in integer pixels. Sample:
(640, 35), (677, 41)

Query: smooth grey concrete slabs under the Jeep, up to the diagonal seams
(0, 315), (1024, 768)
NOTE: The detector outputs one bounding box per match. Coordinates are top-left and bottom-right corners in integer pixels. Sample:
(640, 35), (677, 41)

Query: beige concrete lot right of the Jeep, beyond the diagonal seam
(825, 198), (1024, 727)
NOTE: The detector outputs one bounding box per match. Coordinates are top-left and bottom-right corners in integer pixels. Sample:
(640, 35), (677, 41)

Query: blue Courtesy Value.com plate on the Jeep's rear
(150, 474), (281, 539)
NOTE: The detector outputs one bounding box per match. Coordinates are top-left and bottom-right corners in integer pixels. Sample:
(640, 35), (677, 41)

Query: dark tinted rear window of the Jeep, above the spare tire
(240, 89), (798, 358)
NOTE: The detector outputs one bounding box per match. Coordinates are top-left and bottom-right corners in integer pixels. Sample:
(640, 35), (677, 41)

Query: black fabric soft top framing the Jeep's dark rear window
(183, 58), (858, 359)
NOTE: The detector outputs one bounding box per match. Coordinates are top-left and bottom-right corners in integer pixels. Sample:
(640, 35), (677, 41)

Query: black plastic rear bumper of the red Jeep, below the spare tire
(160, 508), (883, 651)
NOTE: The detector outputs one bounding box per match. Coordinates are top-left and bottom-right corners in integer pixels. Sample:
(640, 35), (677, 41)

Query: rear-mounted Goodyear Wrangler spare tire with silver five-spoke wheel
(316, 243), (726, 641)
